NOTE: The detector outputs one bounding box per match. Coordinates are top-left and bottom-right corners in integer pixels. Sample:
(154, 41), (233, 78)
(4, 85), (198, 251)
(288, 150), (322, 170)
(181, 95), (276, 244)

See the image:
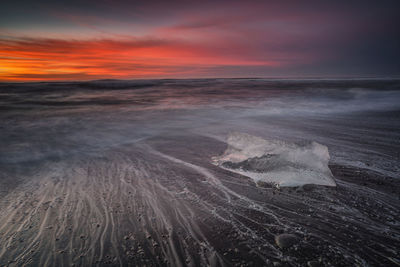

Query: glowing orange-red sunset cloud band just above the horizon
(0, 38), (279, 81)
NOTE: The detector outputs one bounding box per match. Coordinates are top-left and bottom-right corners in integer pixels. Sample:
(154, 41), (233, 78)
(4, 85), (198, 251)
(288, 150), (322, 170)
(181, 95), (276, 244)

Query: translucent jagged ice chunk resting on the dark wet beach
(213, 132), (336, 186)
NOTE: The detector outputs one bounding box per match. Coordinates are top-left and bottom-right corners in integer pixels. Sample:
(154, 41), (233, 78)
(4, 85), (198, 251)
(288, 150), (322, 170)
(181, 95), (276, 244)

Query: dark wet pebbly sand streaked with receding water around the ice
(0, 134), (400, 266)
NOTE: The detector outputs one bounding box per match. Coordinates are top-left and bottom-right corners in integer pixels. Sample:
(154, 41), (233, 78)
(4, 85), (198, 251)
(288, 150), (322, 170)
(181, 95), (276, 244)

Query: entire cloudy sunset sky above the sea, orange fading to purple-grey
(0, 0), (400, 81)
